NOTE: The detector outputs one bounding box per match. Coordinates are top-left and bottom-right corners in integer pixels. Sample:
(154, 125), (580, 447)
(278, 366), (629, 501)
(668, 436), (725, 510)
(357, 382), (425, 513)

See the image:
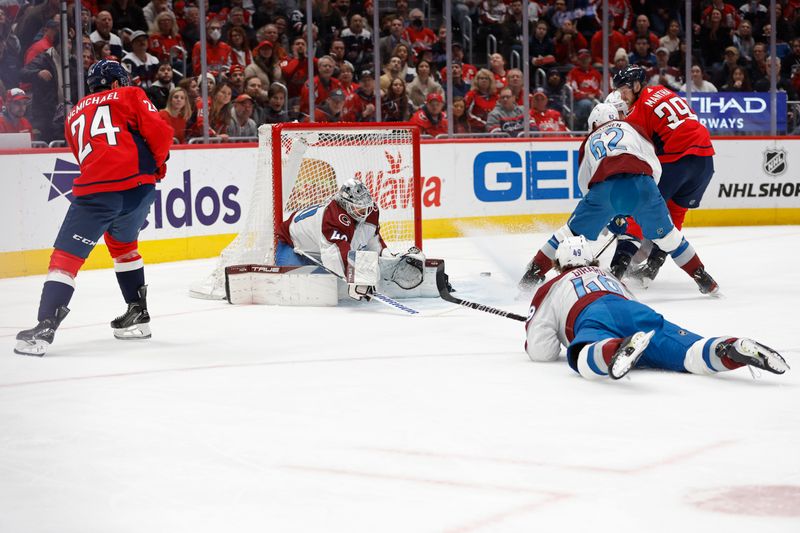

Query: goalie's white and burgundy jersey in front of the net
(278, 200), (386, 276)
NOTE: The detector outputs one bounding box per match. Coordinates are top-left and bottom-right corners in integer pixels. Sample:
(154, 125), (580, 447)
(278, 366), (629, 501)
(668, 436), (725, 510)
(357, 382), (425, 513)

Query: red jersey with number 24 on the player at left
(64, 87), (173, 196)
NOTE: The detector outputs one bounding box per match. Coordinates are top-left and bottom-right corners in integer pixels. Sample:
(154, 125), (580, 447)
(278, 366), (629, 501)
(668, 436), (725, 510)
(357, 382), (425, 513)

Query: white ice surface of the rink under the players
(0, 226), (800, 533)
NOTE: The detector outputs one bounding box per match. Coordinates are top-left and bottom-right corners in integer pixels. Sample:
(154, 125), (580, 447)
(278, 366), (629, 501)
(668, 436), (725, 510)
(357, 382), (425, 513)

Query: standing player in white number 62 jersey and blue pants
(520, 103), (719, 294)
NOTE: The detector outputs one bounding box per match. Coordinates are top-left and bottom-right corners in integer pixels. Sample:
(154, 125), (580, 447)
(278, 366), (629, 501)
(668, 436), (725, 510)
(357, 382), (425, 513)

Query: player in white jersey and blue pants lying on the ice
(525, 236), (789, 379)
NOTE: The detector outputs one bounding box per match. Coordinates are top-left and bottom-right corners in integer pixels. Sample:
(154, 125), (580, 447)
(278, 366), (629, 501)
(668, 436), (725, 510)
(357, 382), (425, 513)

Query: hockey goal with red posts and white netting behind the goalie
(190, 123), (422, 299)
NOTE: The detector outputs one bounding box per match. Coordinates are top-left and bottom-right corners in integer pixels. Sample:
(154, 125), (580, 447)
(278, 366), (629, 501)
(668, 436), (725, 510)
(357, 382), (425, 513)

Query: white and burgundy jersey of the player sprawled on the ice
(525, 266), (636, 361)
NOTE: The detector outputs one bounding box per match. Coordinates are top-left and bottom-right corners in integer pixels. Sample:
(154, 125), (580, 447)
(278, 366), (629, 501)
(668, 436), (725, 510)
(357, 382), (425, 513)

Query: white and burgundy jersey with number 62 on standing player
(578, 120), (661, 194)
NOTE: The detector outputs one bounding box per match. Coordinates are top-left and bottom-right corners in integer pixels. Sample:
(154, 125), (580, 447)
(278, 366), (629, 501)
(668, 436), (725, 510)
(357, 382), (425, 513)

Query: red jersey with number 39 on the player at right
(625, 85), (714, 163)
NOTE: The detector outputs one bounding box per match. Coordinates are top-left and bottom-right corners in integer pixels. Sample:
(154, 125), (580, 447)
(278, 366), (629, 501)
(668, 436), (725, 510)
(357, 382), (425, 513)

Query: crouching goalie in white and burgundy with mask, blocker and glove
(275, 179), (425, 300)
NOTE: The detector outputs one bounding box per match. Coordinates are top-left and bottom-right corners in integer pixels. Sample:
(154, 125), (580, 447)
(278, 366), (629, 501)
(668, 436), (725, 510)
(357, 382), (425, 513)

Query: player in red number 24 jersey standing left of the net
(14, 59), (172, 356)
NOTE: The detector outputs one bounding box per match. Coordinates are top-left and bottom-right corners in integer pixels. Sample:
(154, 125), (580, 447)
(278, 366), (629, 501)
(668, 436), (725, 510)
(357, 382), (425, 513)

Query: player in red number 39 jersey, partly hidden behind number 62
(612, 65), (714, 280)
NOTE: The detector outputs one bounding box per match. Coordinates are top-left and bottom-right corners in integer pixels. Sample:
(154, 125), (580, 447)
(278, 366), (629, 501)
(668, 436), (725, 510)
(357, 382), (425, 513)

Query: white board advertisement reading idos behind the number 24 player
(0, 148), (256, 252)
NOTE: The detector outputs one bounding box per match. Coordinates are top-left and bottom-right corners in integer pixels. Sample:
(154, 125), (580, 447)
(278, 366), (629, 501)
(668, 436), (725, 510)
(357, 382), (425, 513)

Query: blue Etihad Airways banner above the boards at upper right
(680, 92), (787, 135)
